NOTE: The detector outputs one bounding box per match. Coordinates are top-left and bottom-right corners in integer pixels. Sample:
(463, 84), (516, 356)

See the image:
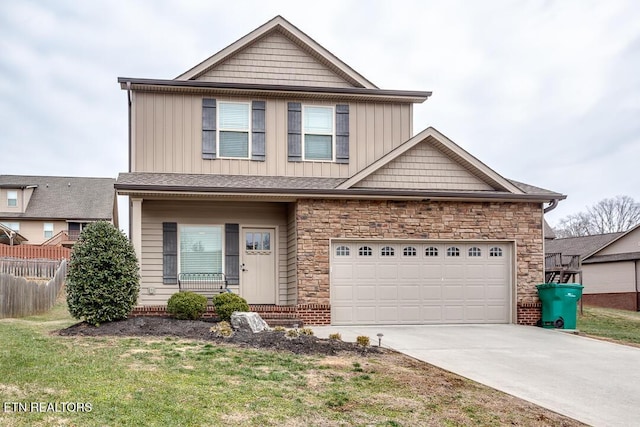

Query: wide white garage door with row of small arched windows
(331, 241), (511, 325)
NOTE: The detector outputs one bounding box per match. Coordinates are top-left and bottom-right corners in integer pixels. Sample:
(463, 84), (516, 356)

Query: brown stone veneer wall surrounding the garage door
(295, 199), (544, 324)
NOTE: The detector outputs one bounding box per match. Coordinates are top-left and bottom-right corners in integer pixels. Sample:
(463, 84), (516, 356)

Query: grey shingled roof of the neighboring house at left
(0, 175), (117, 221)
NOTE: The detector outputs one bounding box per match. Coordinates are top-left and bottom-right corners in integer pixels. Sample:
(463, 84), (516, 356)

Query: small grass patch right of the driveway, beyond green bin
(578, 306), (640, 345)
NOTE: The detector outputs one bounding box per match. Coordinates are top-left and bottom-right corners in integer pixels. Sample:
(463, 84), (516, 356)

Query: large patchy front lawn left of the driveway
(0, 304), (581, 426)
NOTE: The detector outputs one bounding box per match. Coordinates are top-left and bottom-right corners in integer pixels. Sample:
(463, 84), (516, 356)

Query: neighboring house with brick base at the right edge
(545, 224), (640, 311)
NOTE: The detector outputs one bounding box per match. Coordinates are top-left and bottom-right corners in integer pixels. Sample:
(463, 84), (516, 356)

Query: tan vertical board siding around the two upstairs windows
(131, 92), (413, 178)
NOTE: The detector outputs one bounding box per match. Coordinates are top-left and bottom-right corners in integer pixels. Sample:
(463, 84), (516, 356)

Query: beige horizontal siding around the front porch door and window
(138, 200), (290, 306)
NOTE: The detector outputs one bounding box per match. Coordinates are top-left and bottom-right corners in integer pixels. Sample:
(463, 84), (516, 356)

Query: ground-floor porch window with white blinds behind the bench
(179, 225), (224, 273)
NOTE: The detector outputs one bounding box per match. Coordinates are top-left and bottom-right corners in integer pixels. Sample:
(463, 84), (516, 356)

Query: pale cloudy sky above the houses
(0, 0), (640, 231)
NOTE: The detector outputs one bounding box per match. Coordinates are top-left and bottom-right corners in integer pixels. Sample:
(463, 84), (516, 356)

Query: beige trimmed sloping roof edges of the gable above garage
(338, 127), (528, 194)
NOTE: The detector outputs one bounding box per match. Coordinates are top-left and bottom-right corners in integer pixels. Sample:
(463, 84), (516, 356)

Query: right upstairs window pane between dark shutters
(302, 105), (335, 161)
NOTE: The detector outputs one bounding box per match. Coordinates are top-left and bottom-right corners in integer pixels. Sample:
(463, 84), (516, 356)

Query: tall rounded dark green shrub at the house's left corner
(66, 221), (140, 326)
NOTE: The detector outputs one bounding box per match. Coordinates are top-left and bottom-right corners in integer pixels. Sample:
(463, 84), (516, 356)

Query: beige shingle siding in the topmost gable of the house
(197, 32), (353, 87)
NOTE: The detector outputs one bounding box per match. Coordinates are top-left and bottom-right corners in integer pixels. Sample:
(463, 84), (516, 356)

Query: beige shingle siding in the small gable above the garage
(354, 142), (493, 191)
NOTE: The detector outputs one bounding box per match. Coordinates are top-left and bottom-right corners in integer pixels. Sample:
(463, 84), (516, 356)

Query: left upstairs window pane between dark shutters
(218, 102), (251, 159)
